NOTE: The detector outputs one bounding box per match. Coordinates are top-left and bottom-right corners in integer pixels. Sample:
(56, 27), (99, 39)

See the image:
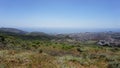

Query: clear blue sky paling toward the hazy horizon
(0, 0), (120, 31)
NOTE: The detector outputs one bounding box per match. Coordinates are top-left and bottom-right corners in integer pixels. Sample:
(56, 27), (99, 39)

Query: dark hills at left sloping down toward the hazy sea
(0, 28), (53, 40)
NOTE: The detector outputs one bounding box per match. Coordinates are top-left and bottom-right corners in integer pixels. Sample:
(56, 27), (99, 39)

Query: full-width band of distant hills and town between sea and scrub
(0, 28), (120, 45)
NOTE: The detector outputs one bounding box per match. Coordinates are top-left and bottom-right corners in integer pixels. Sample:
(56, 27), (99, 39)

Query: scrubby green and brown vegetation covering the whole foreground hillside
(0, 29), (120, 68)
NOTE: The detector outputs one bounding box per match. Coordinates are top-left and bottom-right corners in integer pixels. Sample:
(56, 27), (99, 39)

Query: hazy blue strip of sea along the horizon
(3, 28), (120, 34)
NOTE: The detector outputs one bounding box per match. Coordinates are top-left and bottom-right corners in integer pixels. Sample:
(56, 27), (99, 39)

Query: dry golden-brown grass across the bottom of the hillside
(0, 43), (120, 68)
